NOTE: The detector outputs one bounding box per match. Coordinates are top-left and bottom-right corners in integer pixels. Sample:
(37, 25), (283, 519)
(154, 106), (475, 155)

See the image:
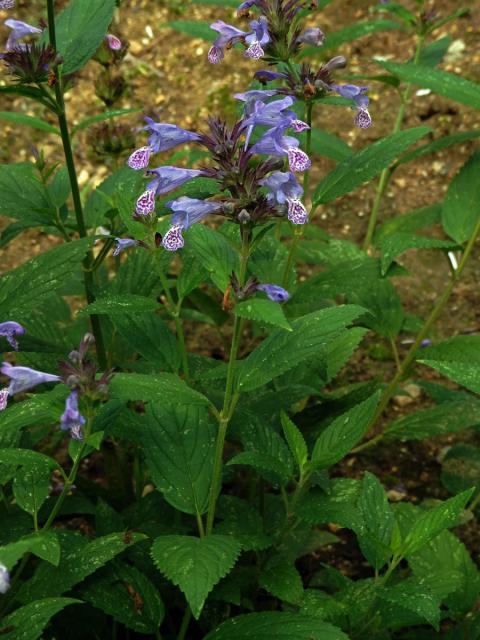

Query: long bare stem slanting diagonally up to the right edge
(352, 219), (480, 453)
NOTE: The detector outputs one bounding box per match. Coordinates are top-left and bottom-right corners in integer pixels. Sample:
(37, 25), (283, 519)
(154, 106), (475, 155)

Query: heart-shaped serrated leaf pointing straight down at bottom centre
(152, 534), (241, 619)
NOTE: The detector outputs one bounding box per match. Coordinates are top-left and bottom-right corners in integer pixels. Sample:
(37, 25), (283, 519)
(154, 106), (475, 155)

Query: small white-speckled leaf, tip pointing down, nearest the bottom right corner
(378, 578), (441, 631)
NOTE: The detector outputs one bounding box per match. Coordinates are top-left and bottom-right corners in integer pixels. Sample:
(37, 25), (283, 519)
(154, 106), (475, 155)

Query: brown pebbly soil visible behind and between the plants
(0, 0), (480, 604)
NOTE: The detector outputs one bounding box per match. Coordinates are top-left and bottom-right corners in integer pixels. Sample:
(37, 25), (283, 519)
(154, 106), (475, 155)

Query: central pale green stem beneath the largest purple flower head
(206, 229), (250, 535)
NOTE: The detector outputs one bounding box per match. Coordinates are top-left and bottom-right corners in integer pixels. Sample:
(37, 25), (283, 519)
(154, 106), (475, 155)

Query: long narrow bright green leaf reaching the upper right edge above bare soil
(375, 60), (480, 109)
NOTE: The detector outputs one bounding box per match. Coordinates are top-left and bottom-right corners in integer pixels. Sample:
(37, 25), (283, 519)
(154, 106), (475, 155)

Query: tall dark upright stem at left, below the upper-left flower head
(47, 0), (107, 369)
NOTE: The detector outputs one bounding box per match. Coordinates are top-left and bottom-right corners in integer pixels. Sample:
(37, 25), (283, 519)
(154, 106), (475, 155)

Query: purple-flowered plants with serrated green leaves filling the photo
(0, 0), (480, 640)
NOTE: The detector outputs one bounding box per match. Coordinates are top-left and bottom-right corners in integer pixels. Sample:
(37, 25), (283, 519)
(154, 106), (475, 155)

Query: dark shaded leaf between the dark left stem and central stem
(112, 313), (181, 373)
